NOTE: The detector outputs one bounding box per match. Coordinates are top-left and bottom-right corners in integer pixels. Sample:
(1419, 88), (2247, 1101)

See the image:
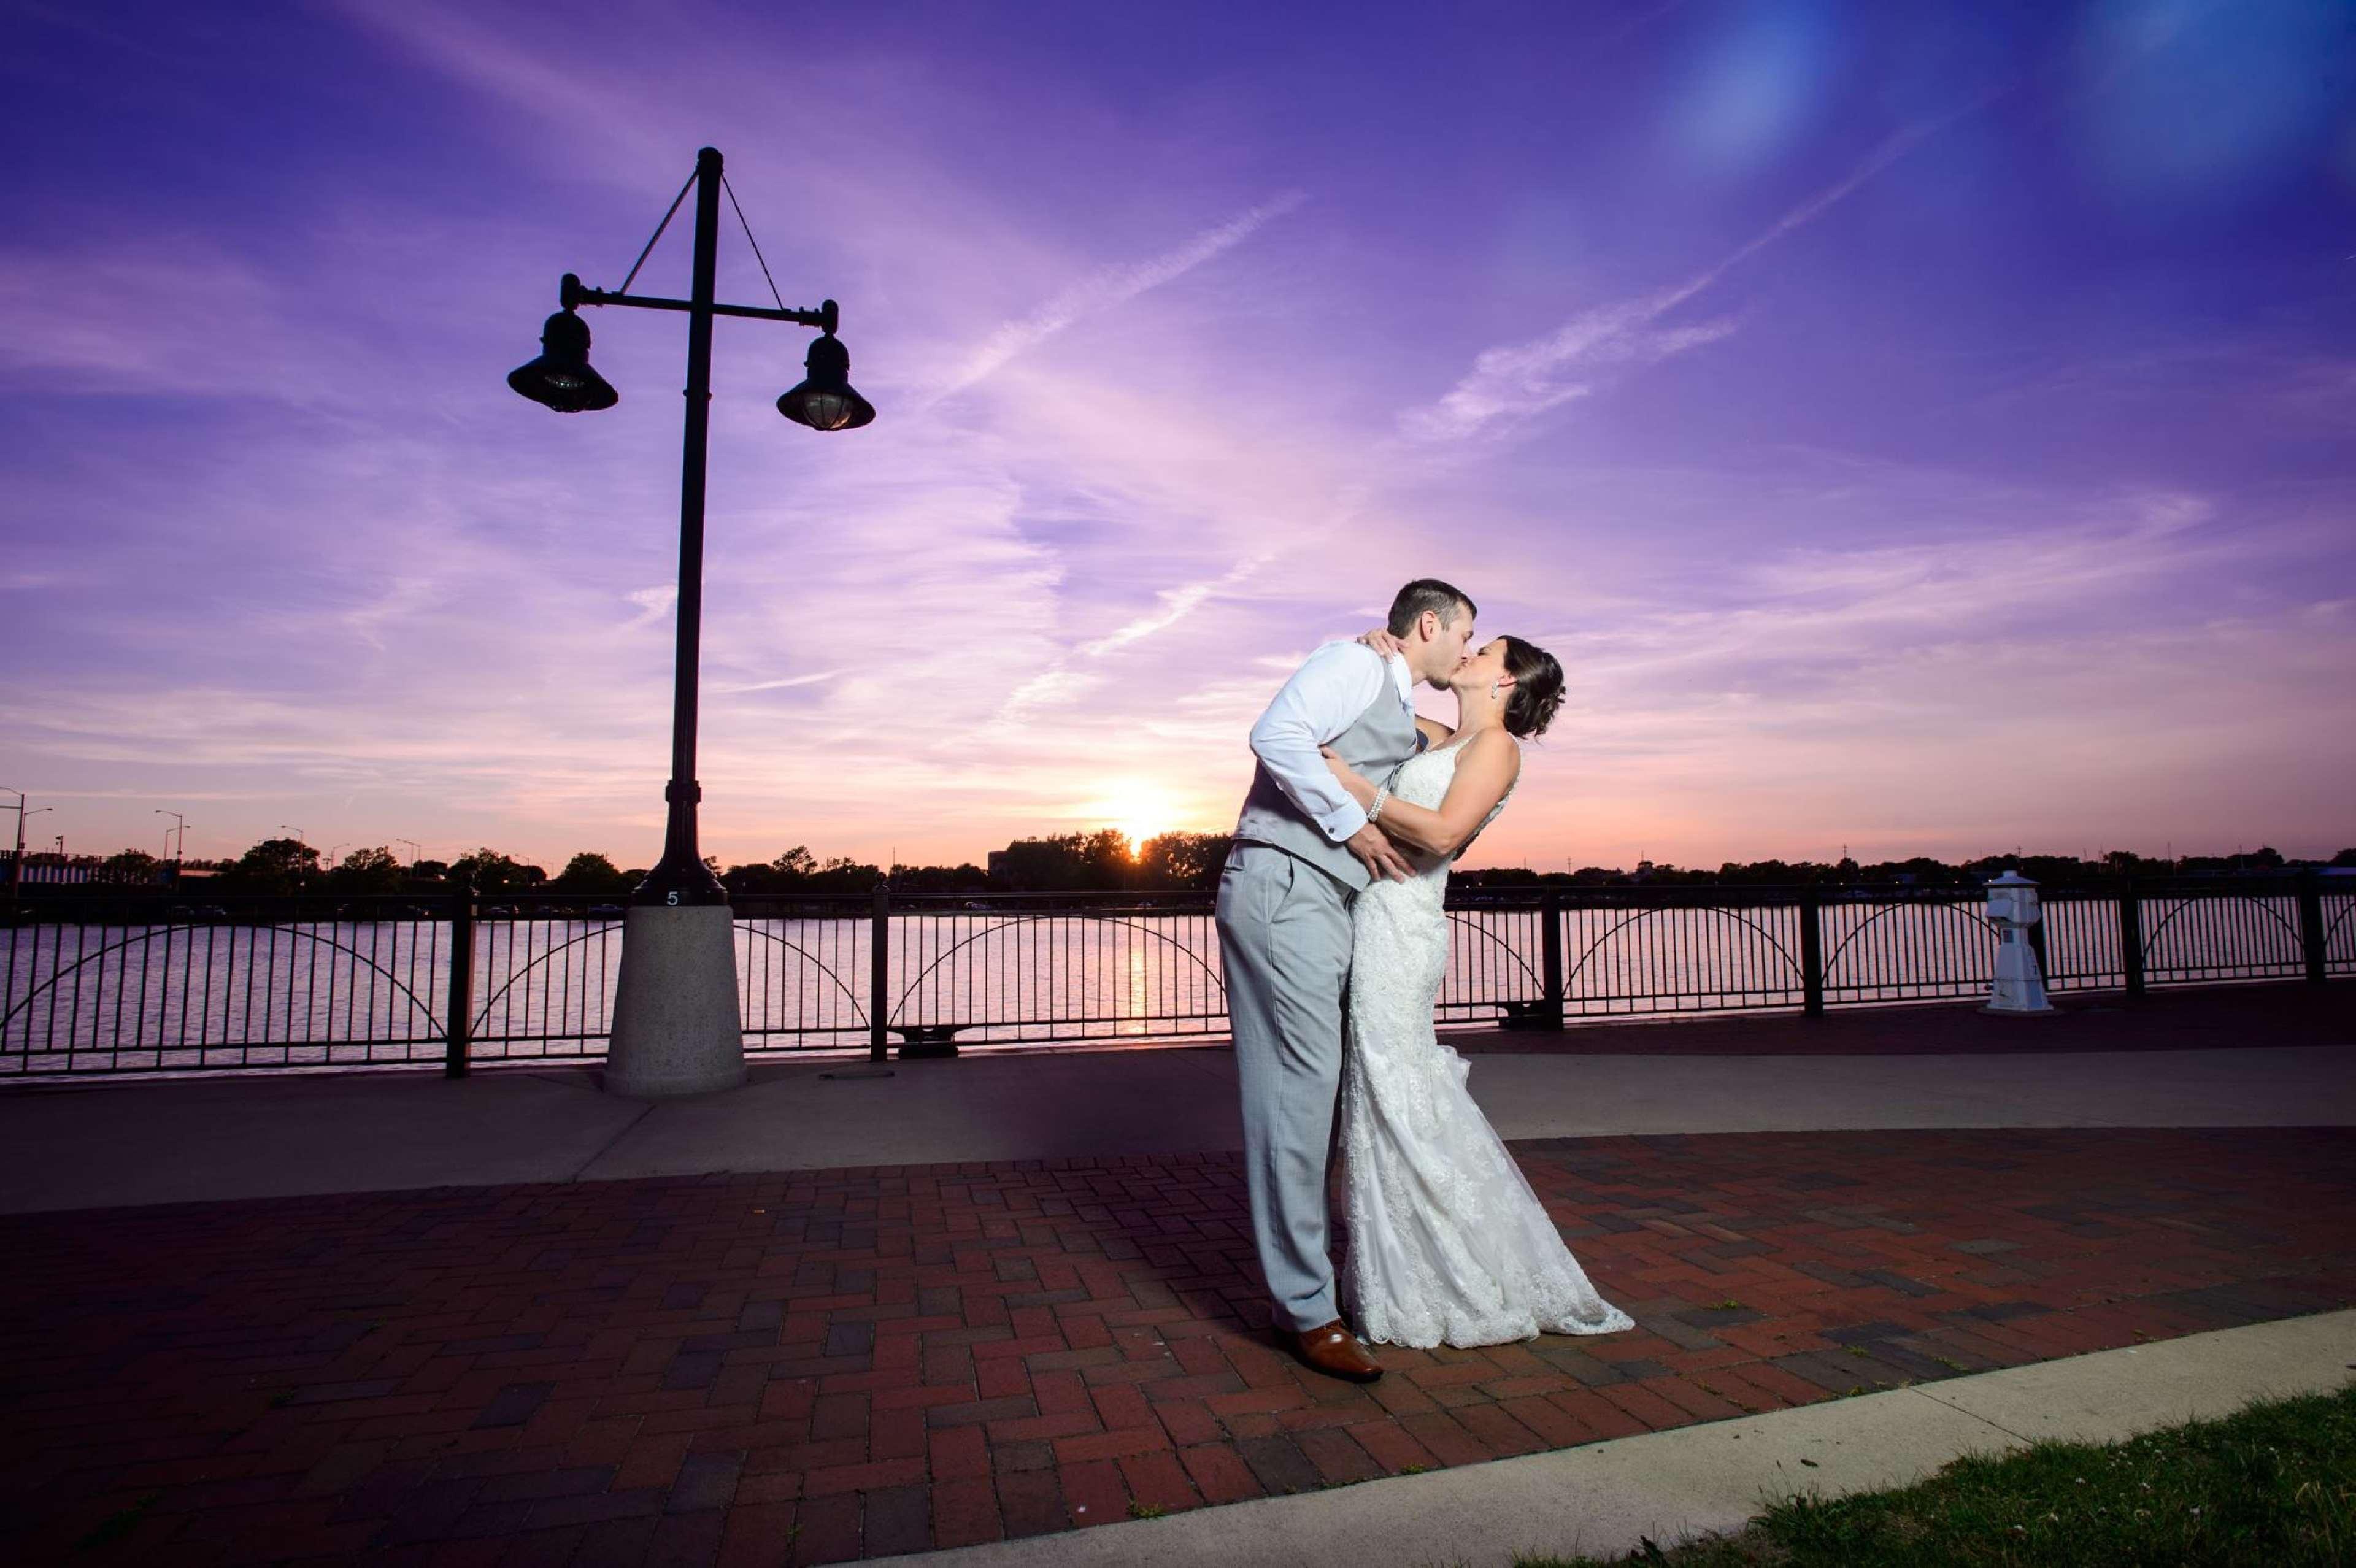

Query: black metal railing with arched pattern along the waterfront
(0, 871), (2356, 1078)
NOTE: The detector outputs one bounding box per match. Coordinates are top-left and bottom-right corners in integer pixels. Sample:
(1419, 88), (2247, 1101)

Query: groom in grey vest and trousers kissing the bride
(1218, 577), (1472, 1382)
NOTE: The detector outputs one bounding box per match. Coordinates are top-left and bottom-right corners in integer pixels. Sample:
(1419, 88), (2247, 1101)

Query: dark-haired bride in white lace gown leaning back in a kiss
(1326, 633), (1635, 1347)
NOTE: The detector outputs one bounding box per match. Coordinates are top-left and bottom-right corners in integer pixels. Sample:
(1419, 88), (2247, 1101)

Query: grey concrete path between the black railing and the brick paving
(0, 1031), (2356, 1212)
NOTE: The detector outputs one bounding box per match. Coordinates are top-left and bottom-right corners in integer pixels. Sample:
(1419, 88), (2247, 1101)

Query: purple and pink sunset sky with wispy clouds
(0, 0), (2356, 866)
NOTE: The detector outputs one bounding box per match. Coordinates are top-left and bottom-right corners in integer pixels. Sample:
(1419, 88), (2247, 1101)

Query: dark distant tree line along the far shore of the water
(26, 829), (2356, 897)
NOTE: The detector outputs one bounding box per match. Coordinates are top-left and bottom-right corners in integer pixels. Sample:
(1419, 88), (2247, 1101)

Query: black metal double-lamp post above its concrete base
(507, 146), (876, 907)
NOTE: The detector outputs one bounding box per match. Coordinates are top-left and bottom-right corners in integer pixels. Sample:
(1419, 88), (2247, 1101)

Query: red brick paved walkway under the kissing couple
(0, 1130), (2356, 1568)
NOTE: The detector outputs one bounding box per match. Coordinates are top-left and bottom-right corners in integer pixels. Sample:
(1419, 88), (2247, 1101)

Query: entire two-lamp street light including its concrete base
(507, 146), (874, 1095)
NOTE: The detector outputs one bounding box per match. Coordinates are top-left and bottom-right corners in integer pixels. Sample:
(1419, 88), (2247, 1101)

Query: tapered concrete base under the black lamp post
(606, 904), (744, 1099)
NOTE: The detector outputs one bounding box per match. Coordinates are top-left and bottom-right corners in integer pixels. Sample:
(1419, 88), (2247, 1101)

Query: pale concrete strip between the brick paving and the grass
(872, 1312), (2356, 1568)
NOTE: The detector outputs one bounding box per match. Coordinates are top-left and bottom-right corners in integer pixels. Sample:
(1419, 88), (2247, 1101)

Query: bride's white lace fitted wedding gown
(1341, 742), (1635, 1347)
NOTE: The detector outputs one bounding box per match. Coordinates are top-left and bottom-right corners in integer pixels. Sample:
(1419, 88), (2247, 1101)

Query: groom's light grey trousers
(1218, 843), (1352, 1328)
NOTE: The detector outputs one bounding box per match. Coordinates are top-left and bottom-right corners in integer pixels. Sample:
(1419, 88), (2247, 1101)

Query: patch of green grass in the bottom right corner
(1515, 1385), (2356, 1568)
